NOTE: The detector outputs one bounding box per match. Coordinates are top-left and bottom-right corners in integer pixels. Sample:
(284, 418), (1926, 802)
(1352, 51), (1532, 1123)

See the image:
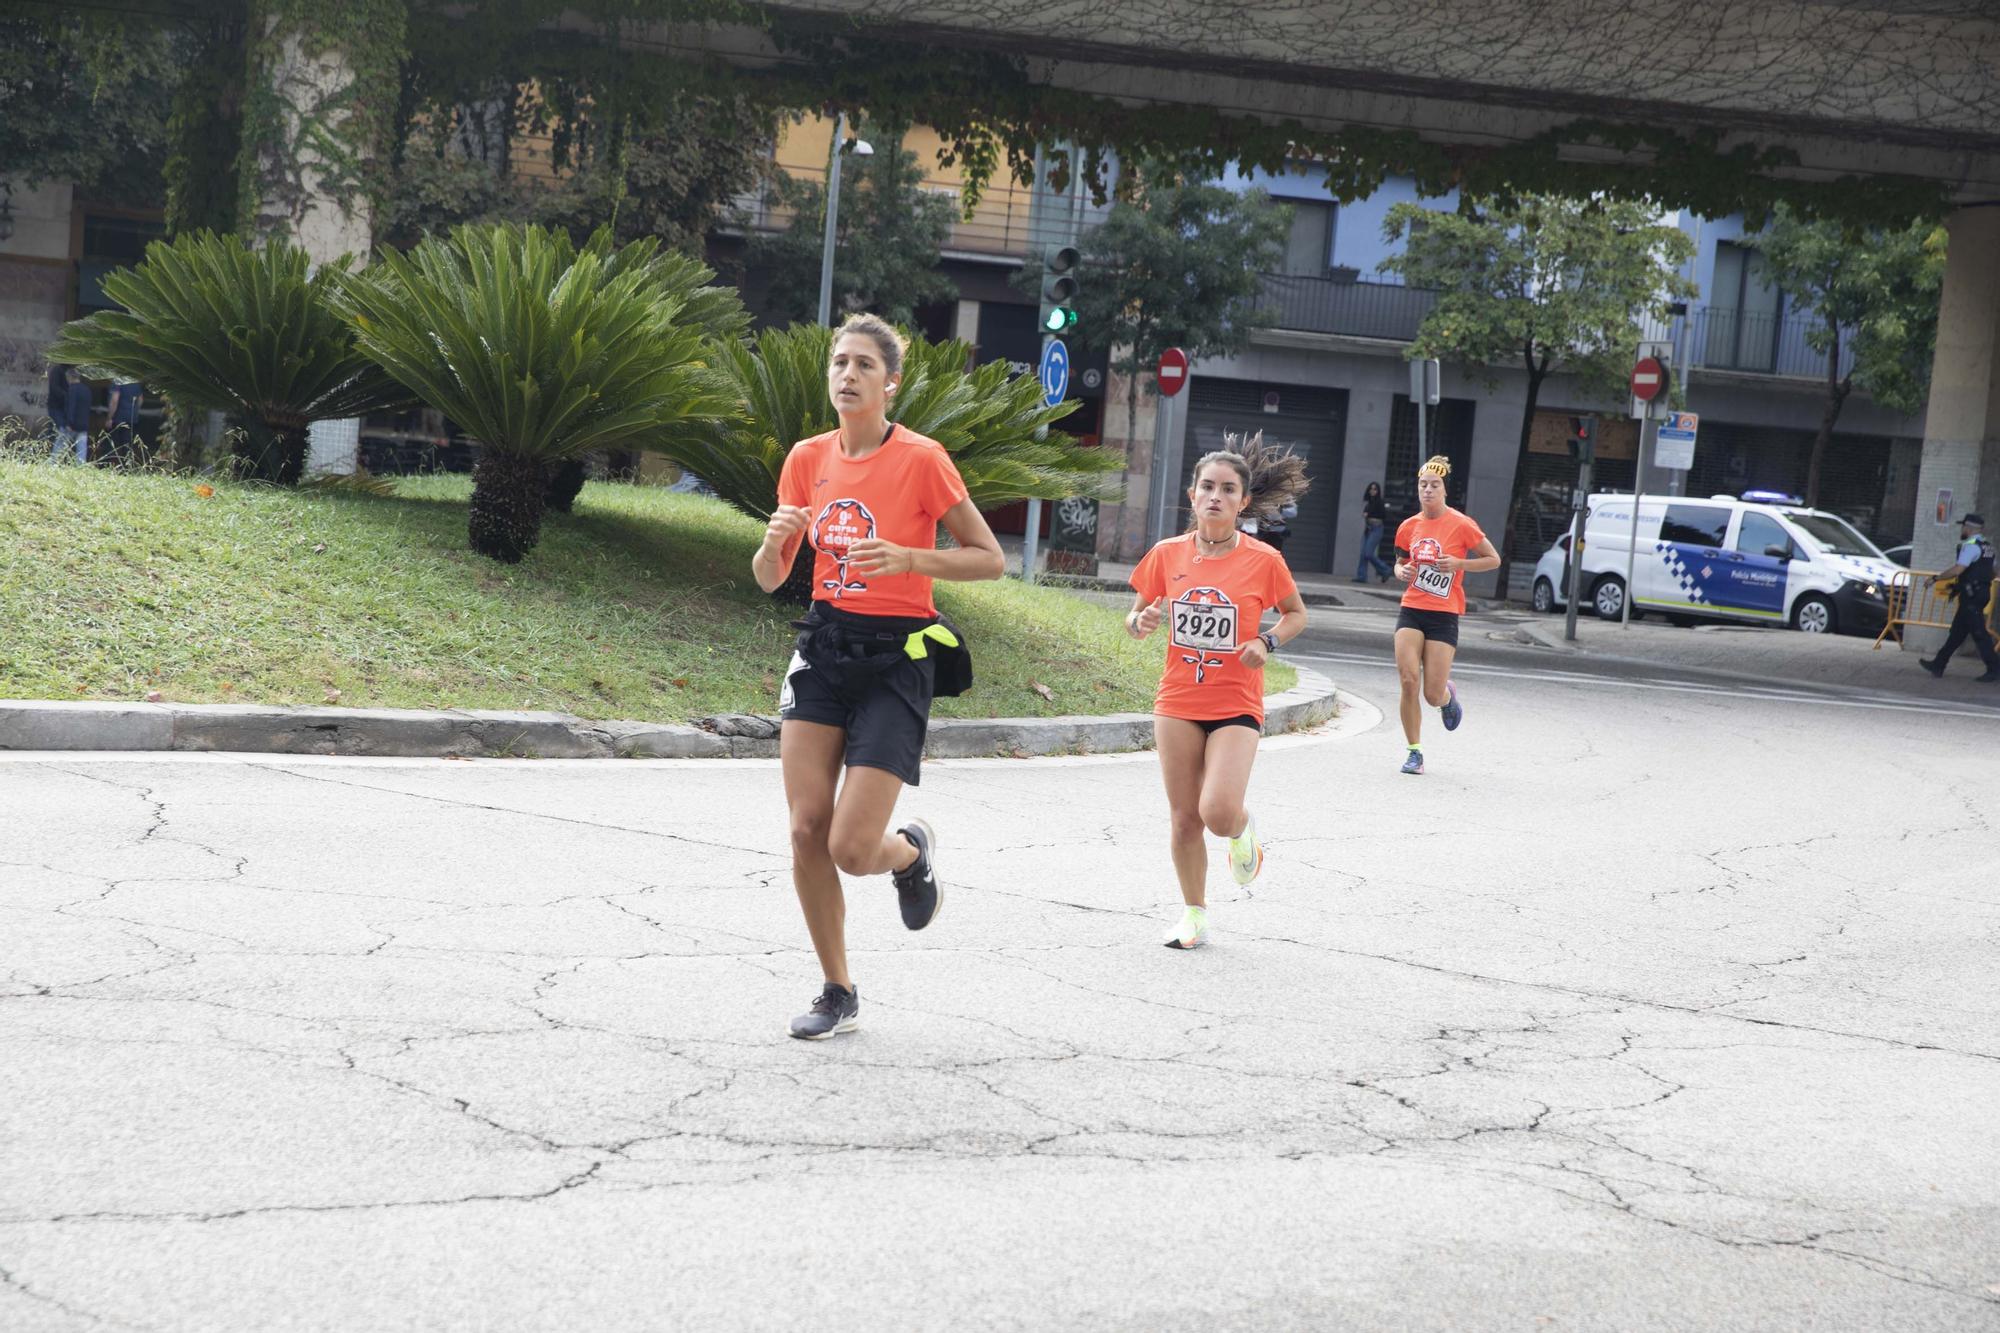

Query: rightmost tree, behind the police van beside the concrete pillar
(1750, 204), (1946, 506)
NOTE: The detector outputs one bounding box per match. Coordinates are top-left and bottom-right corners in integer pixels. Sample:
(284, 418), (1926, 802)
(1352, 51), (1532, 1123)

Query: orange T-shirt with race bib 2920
(1132, 532), (1298, 723)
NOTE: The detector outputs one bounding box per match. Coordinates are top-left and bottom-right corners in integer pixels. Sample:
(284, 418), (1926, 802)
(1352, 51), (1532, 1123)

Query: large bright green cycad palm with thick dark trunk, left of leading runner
(334, 226), (742, 562)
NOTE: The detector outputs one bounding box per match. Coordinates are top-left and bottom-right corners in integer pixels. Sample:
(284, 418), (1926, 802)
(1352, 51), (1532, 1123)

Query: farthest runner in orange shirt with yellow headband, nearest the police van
(1396, 454), (1500, 777)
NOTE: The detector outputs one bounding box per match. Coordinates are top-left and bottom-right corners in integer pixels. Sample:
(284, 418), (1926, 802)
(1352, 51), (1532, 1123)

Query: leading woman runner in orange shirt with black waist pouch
(750, 314), (1006, 1041)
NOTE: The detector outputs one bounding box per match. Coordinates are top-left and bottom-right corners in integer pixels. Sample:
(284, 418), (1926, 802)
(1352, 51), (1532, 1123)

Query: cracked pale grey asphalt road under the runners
(0, 644), (2000, 1333)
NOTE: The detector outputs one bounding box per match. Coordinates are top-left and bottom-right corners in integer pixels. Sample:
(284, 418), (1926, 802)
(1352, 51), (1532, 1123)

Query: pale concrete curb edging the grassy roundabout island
(0, 667), (1336, 759)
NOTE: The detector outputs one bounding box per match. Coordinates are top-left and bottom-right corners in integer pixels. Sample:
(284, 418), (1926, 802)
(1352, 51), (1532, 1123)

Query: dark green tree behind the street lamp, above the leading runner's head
(746, 126), (958, 324)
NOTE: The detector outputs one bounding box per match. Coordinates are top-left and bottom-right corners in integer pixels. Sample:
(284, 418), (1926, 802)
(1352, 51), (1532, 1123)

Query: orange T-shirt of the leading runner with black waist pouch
(778, 426), (966, 618)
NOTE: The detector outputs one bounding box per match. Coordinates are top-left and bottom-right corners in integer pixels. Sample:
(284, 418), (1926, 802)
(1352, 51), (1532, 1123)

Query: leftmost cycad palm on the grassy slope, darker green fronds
(48, 232), (410, 484)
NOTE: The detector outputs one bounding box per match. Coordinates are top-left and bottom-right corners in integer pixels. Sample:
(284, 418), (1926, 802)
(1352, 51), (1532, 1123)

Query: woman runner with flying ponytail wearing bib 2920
(1126, 450), (1306, 949)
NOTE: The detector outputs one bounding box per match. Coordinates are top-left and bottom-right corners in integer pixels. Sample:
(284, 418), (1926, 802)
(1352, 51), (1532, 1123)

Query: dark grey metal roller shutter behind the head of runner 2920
(1174, 376), (1348, 572)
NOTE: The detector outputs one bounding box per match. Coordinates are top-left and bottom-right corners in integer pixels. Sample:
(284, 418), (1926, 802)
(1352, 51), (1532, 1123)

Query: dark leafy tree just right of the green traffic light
(1056, 168), (1292, 486)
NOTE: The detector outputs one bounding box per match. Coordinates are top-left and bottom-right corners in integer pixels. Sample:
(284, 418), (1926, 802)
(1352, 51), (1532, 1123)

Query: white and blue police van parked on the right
(1534, 490), (1896, 634)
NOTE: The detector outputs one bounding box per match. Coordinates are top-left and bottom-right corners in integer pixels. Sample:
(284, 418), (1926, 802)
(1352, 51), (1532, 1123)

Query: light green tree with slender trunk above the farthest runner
(1380, 194), (1696, 594)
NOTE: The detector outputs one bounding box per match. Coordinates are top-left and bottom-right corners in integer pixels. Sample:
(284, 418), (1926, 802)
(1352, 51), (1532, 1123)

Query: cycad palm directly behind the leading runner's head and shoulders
(662, 324), (1120, 600)
